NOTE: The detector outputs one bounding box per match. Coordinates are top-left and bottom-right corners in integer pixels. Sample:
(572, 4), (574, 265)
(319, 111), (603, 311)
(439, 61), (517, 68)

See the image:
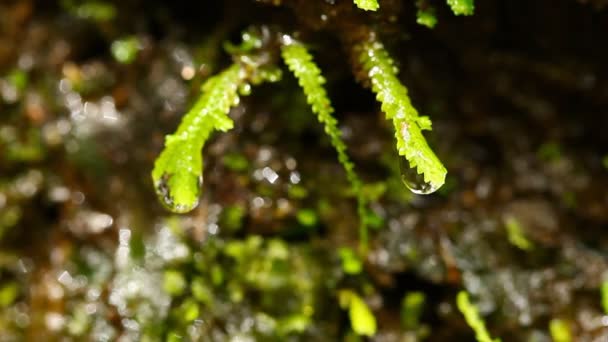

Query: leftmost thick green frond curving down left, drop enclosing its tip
(152, 64), (243, 213)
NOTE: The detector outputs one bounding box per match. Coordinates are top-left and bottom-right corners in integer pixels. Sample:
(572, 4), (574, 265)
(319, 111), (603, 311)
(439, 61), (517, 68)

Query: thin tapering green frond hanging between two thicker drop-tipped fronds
(281, 40), (367, 248)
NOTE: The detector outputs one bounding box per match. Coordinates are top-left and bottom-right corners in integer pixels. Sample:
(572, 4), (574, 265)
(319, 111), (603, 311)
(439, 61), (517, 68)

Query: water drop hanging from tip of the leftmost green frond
(154, 174), (203, 214)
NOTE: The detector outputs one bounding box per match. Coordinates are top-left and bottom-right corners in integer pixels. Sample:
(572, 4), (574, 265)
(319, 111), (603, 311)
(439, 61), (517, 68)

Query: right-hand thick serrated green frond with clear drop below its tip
(359, 41), (447, 190)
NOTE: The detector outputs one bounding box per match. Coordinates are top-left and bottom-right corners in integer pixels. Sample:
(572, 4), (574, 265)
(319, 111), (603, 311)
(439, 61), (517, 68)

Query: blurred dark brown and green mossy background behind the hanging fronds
(0, 0), (608, 342)
